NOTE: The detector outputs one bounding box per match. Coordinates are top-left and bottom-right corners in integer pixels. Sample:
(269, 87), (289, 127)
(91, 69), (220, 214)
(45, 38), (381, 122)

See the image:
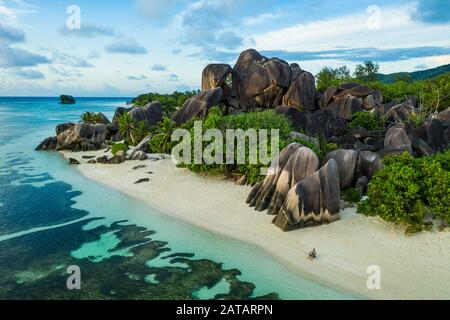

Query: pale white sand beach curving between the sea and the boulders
(63, 151), (450, 299)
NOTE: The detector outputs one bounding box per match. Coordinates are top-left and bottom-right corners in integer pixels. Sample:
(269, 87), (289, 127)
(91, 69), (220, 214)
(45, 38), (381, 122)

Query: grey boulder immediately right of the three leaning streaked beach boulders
(322, 149), (358, 190)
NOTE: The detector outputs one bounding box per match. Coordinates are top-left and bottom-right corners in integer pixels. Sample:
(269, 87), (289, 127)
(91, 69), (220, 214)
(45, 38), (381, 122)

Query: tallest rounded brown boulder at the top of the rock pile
(232, 49), (292, 111)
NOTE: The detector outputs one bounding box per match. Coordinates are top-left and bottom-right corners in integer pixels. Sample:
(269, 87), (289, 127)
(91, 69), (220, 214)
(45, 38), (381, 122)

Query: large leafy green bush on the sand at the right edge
(359, 150), (450, 231)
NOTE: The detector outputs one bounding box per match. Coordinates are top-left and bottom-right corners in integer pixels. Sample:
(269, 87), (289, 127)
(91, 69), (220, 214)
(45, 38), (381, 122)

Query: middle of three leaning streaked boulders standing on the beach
(268, 147), (320, 215)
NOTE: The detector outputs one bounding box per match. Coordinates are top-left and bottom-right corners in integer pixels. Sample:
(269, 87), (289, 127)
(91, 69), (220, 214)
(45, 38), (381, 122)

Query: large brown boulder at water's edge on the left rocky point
(56, 123), (108, 151)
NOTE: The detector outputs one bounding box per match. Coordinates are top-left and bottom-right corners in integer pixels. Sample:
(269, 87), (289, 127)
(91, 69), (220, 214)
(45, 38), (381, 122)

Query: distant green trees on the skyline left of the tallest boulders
(131, 91), (198, 118)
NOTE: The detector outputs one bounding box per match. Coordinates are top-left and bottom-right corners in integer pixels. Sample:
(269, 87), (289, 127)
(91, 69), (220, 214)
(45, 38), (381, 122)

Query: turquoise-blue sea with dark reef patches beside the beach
(0, 98), (352, 299)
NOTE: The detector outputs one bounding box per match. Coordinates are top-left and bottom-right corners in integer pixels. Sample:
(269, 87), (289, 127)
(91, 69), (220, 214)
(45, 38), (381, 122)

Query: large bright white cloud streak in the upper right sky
(252, 6), (450, 51)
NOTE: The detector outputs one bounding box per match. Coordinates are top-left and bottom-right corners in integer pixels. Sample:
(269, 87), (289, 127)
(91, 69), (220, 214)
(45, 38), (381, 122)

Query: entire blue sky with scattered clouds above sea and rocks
(0, 0), (450, 97)
